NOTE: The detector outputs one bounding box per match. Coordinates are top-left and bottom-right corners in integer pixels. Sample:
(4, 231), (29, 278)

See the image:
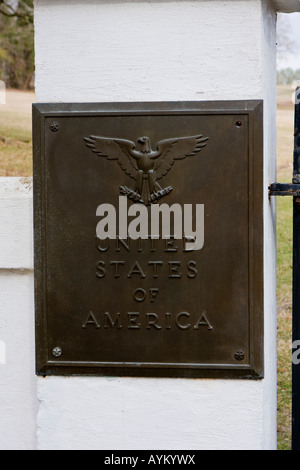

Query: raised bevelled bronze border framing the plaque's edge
(32, 100), (264, 379)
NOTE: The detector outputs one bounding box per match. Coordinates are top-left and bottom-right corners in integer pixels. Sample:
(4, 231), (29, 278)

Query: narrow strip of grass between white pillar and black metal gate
(276, 83), (294, 450)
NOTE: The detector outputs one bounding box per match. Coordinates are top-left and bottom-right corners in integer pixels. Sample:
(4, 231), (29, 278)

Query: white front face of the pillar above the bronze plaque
(35, 0), (262, 101)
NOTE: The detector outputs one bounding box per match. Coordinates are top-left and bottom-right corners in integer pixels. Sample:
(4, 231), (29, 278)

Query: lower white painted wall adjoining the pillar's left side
(0, 178), (38, 450)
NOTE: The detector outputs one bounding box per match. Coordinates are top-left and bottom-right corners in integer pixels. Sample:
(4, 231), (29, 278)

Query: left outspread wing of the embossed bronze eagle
(84, 135), (138, 179)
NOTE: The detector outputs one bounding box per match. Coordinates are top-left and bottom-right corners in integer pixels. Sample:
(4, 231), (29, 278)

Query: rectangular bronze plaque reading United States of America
(33, 101), (263, 378)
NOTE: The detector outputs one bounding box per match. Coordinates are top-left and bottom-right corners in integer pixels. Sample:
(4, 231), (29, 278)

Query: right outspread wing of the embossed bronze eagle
(154, 135), (208, 179)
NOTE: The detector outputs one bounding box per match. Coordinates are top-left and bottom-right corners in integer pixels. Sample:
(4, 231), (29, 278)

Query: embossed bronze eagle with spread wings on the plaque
(84, 135), (209, 205)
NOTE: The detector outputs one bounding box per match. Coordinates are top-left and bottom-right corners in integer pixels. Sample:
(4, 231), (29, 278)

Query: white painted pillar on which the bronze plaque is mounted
(30, 0), (296, 449)
